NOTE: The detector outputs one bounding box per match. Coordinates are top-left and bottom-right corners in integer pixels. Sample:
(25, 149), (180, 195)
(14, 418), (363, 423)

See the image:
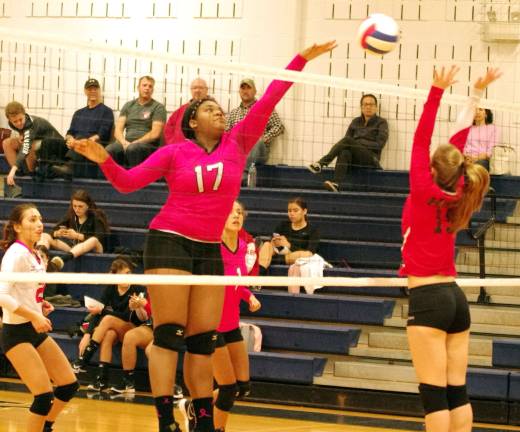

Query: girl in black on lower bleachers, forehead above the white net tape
(73, 257), (151, 391)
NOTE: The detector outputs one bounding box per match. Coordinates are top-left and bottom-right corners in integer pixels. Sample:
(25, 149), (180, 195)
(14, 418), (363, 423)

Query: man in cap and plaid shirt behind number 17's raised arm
(226, 78), (284, 179)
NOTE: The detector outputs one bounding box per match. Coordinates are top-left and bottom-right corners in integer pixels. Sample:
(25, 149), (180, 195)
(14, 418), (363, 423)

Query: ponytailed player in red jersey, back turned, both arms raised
(400, 67), (500, 432)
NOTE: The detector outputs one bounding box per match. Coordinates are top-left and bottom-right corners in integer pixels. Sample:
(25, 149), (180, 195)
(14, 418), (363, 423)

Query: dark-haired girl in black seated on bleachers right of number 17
(258, 198), (320, 276)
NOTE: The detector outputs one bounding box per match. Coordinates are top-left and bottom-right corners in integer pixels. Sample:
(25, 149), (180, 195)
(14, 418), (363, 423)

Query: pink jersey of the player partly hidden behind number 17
(217, 237), (251, 333)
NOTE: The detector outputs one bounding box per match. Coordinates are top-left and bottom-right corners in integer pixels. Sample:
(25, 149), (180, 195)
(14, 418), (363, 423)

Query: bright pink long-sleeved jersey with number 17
(101, 55), (306, 243)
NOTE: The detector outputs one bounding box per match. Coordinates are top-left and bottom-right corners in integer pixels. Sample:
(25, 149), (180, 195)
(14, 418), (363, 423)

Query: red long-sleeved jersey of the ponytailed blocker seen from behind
(399, 87), (481, 276)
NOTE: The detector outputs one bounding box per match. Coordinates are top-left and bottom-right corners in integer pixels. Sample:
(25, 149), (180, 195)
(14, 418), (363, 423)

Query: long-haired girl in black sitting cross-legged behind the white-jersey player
(39, 189), (110, 267)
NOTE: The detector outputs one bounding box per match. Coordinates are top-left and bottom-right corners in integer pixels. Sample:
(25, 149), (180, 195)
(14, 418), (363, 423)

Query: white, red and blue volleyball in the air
(357, 14), (399, 55)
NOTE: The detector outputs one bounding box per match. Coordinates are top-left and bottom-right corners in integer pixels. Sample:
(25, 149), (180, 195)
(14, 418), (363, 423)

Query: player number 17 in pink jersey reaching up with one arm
(74, 41), (336, 432)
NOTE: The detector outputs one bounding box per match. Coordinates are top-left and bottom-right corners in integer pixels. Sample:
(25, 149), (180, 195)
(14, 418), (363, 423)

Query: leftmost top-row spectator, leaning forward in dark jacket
(2, 101), (63, 186)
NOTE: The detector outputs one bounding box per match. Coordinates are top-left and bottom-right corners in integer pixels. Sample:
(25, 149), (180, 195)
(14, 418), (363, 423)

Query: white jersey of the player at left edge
(0, 241), (45, 324)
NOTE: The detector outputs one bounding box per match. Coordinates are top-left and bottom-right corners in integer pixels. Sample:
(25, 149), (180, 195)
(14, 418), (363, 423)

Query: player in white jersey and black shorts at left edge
(0, 204), (79, 432)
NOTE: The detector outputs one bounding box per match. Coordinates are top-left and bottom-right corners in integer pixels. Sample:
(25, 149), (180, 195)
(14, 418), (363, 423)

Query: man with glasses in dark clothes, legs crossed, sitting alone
(308, 94), (388, 192)
